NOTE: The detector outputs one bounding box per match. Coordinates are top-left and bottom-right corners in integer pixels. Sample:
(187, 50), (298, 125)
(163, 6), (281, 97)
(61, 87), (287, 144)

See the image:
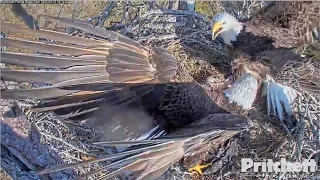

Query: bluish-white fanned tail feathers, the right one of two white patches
(262, 75), (299, 121)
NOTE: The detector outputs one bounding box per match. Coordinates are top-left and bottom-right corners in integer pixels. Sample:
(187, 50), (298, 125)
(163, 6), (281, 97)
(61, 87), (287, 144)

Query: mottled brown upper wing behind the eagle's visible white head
(245, 1), (320, 48)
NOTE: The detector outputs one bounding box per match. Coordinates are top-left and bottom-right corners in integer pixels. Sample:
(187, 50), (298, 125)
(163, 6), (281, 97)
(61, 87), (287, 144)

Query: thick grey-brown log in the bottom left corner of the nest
(0, 100), (75, 179)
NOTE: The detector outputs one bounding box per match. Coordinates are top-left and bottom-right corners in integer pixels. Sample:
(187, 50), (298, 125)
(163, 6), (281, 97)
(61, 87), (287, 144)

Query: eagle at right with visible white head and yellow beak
(212, 1), (320, 123)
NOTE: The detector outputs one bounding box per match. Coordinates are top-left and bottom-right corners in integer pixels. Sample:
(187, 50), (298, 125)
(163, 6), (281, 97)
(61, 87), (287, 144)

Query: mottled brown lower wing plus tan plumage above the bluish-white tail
(233, 48), (320, 95)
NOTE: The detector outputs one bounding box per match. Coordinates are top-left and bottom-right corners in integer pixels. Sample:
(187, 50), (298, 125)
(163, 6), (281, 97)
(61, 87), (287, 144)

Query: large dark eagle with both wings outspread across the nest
(1, 15), (258, 179)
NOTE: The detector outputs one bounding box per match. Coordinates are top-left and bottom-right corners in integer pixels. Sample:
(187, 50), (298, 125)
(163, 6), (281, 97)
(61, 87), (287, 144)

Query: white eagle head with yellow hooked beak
(212, 12), (243, 45)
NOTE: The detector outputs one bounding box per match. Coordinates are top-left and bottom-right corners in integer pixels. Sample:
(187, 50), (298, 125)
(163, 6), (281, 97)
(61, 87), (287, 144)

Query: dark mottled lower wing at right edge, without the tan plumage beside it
(256, 49), (320, 94)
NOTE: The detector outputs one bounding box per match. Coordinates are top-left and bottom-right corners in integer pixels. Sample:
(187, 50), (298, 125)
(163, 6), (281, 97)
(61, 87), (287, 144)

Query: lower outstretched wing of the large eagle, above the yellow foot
(39, 114), (248, 179)
